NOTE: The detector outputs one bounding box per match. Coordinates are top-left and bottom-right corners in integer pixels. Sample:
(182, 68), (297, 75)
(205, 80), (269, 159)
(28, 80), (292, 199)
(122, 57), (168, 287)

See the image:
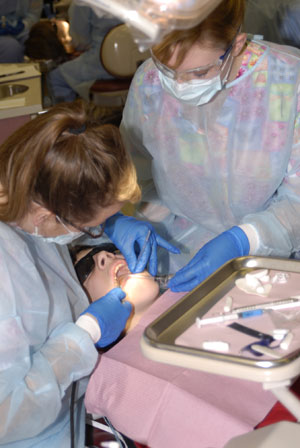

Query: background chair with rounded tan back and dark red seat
(90, 24), (150, 110)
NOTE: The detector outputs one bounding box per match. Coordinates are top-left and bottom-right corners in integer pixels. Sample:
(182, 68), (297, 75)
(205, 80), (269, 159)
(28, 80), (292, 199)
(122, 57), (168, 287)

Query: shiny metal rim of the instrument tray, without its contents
(141, 256), (300, 383)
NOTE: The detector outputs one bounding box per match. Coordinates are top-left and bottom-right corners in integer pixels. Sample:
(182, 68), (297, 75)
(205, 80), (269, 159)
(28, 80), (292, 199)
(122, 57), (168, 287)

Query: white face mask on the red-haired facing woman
(158, 50), (233, 106)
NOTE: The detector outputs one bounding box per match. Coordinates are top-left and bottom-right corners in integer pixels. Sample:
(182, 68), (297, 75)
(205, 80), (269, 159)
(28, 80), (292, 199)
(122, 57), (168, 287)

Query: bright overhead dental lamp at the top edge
(80, 0), (221, 51)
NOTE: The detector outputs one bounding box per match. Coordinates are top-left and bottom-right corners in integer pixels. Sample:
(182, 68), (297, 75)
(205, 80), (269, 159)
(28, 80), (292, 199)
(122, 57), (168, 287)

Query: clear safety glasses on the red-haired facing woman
(150, 44), (233, 82)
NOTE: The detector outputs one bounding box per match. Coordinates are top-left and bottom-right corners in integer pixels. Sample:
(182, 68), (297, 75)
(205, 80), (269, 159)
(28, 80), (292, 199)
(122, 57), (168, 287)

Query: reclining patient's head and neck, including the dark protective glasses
(72, 243), (159, 331)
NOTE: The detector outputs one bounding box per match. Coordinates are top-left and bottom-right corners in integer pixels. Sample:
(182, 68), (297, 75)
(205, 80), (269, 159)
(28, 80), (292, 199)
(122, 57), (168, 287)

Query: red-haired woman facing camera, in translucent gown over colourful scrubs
(121, 0), (300, 291)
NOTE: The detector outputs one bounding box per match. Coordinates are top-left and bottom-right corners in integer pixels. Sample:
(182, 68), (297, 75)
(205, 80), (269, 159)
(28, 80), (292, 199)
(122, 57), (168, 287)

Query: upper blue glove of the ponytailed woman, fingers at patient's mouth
(105, 213), (180, 275)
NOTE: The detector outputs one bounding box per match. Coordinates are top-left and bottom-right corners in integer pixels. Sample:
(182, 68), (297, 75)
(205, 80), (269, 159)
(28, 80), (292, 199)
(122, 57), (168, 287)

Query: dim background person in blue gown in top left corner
(0, 0), (43, 63)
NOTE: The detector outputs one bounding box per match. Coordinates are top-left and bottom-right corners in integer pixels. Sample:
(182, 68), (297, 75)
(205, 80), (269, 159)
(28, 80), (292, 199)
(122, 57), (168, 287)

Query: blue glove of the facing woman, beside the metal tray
(168, 226), (250, 292)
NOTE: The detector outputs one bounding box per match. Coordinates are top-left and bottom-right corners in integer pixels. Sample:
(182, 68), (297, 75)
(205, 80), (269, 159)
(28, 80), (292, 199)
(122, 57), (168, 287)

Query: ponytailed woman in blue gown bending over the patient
(0, 101), (177, 448)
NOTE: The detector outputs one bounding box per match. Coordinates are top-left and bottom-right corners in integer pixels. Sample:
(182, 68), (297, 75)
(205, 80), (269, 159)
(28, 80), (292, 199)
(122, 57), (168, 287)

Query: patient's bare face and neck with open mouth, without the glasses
(77, 250), (159, 330)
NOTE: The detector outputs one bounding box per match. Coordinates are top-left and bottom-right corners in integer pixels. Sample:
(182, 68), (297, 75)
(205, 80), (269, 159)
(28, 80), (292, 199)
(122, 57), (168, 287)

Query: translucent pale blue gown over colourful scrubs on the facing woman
(121, 41), (300, 272)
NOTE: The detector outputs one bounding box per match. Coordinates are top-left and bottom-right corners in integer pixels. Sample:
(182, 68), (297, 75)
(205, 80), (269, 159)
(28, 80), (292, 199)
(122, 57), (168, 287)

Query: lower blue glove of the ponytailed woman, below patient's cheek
(81, 288), (132, 348)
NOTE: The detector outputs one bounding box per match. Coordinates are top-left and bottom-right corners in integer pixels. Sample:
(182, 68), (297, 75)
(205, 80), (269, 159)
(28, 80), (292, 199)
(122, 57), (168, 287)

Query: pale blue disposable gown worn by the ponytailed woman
(0, 223), (97, 448)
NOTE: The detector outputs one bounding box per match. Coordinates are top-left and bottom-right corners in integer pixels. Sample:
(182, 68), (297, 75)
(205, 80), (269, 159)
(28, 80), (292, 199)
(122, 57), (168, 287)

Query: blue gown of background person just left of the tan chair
(58, 1), (120, 100)
